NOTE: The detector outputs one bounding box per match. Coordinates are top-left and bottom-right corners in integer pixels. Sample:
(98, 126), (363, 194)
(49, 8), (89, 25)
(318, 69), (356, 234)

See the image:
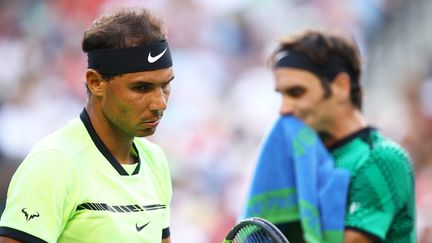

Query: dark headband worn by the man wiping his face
(274, 49), (354, 81)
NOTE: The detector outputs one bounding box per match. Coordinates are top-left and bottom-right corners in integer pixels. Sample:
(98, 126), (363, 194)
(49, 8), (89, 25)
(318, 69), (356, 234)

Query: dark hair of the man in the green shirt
(269, 30), (362, 110)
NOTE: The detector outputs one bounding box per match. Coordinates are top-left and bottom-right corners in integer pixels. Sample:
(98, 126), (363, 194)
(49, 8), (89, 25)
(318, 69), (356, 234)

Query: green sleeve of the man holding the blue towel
(345, 144), (413, 239)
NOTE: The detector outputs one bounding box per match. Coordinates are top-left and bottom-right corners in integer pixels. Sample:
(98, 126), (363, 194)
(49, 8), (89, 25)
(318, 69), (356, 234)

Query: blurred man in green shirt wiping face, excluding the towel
(270, 31), (415, 243)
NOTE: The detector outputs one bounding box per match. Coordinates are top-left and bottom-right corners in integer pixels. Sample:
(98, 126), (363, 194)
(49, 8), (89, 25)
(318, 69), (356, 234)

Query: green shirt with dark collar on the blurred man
(330, 127), (415, 243)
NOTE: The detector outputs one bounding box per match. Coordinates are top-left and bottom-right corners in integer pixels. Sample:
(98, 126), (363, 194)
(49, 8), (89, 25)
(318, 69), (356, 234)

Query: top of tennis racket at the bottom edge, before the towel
(223, 217), (289, 243)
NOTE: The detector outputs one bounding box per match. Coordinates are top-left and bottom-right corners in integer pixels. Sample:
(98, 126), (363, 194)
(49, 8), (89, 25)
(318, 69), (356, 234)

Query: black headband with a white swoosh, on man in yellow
(87, 40), (172, 75)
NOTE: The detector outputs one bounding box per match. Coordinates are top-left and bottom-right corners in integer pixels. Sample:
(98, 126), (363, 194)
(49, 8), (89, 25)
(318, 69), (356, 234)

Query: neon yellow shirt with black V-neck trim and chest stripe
(0, 111), (172, 242)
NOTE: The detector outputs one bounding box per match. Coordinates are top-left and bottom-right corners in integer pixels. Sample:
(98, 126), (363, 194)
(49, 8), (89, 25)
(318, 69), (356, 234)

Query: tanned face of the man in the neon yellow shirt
(101, 68), (174, 137)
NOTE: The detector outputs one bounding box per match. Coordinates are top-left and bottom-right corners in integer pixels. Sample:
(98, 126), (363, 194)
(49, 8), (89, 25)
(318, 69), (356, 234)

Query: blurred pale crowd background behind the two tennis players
(0, 0), (432, 243)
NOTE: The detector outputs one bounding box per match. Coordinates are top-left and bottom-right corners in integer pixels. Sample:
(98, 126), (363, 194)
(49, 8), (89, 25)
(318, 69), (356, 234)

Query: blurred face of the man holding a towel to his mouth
(274, 67), (336, 132)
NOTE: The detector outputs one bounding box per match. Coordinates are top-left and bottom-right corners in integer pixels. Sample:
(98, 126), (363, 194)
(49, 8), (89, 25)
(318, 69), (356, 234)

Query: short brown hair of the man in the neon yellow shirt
(82, 7), (167, 80)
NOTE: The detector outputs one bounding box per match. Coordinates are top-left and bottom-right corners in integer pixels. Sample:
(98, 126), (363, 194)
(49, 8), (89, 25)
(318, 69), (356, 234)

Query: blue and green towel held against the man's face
(243, 116), (349, 243)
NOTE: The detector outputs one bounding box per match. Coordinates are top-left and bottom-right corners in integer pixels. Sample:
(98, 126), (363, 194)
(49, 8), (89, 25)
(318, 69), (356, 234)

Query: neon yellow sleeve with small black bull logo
(0, 151), (79, 242)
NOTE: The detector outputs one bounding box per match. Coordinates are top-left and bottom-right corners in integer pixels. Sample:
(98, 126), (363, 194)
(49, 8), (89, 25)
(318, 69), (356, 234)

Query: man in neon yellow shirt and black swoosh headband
(0, 8), (174, 243)
